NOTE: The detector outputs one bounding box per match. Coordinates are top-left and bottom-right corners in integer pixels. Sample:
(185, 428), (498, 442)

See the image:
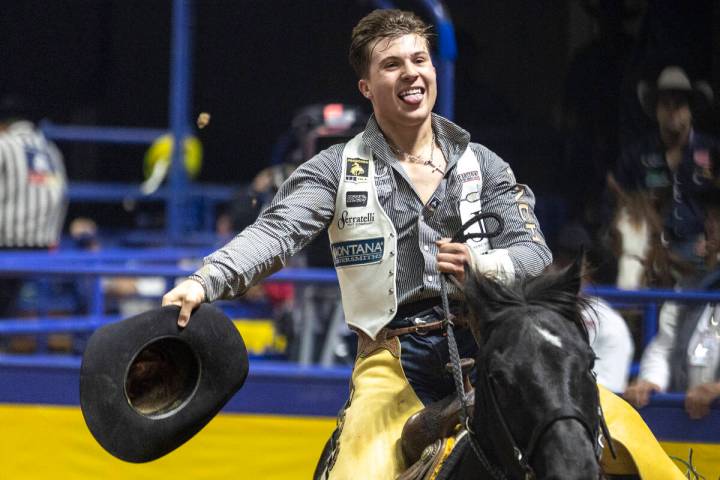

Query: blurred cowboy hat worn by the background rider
(637, 65), (713, 119)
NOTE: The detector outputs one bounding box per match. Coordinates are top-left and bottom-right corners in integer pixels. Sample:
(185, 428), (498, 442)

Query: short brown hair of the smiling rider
(348, 9), (431, 78)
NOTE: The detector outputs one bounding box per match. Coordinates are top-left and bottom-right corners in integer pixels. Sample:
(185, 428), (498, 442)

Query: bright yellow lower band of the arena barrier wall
(0, 405), (720, 480)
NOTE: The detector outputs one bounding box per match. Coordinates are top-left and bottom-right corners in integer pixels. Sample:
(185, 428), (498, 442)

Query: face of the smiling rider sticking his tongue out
(358, 35), (437, 126)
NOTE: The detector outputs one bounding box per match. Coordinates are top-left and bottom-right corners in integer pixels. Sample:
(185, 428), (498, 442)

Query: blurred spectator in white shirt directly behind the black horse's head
(551, 224), (635, 392)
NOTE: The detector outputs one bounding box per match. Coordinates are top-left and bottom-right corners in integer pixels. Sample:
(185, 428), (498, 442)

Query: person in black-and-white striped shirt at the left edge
(0, 95), (67, 318)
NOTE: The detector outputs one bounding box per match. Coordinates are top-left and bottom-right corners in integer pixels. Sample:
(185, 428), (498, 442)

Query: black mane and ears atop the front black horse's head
(465, 261), (589, 343)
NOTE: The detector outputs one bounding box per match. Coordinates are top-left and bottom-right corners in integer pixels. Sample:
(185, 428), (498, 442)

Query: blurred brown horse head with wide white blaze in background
(607, 175), (688, 290)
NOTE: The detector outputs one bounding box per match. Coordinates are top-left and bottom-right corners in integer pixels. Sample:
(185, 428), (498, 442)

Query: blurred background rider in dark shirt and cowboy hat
(616, 66), (720, 286)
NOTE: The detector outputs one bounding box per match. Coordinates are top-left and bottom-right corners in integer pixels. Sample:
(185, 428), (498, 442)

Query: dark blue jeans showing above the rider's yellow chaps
(400, 328), (478, 405)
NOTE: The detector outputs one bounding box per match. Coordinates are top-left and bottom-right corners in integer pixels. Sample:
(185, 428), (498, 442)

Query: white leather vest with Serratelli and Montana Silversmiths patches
(328, 133), (489, 339)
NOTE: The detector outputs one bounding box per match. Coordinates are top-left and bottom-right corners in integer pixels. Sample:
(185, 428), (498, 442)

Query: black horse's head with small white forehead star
(458, 261), (601, 479)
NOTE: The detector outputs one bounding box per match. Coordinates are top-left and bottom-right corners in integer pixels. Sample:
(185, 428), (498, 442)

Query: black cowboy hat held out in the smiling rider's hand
(80, 304), (248, 463)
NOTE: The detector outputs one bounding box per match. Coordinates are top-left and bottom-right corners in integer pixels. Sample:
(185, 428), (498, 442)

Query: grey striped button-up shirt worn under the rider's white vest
(190, 115), (552, 305)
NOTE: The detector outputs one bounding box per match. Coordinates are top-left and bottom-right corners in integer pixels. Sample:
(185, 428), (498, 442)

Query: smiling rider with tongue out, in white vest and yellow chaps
(163, 10), (551, 479)
